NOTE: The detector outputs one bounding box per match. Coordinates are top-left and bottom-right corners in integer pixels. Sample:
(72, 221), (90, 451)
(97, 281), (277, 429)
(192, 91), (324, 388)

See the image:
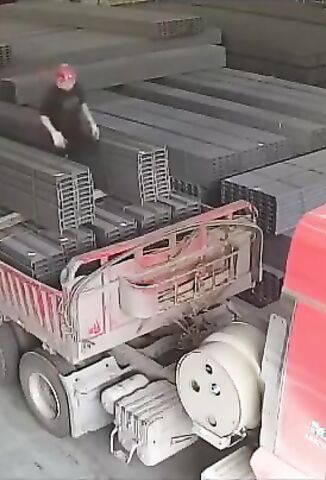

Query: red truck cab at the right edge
(251, 205), (326, 480)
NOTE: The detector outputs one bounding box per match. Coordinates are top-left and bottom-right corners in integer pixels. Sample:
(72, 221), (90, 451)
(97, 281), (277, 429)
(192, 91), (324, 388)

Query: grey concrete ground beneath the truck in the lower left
(0, 389), (218, 480)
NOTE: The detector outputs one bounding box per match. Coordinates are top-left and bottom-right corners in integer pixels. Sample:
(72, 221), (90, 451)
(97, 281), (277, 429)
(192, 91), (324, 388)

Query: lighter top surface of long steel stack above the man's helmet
(7, 29), (221, 75)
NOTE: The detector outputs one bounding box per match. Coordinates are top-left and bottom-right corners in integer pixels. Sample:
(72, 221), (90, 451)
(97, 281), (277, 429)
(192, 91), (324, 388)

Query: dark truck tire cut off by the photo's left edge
(0, 323), (20, 385)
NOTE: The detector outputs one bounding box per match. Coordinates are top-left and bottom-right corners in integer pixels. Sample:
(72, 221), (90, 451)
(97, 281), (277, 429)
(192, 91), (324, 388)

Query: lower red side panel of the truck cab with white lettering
(275, 303), (326, 479)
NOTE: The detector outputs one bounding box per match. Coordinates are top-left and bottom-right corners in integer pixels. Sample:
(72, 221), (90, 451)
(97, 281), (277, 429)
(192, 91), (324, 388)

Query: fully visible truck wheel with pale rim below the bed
(19, 352), (70, 438)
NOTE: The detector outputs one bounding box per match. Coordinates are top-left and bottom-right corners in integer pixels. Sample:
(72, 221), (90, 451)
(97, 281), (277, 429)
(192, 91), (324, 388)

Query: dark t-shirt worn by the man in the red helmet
(40, 83), (85, 137)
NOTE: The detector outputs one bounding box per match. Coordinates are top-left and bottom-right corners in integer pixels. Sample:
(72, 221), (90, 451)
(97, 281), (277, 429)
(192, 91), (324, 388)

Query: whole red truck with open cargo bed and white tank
(0, 197), (326, 480)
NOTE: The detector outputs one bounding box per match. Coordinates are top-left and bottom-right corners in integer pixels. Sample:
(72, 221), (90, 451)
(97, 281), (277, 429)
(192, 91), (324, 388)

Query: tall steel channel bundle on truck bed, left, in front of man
(0, 138), (95, 234)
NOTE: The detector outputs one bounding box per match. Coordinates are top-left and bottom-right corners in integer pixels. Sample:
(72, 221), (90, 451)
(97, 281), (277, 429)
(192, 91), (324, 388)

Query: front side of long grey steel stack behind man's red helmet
(0, 45), (225, 106)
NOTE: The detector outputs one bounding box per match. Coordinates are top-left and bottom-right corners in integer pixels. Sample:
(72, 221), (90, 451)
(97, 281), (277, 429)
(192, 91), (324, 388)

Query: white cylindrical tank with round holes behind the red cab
(177, 322), (265, 437)
